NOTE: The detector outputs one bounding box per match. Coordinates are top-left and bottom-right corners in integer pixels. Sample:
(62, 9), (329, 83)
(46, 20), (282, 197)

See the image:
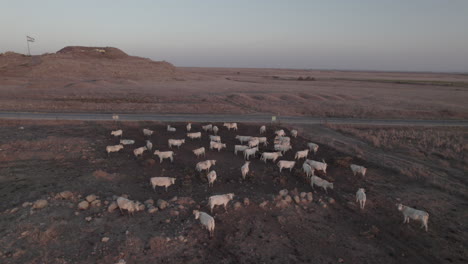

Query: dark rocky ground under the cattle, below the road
(0, 121), (468, 263)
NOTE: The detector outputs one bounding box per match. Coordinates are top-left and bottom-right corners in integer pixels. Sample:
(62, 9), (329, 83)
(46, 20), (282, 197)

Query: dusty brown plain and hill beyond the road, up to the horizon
(0, 47), (468, 119)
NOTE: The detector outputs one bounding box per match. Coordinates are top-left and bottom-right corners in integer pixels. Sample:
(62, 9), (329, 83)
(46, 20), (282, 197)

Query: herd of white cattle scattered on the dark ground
(106, 123), (429, 236)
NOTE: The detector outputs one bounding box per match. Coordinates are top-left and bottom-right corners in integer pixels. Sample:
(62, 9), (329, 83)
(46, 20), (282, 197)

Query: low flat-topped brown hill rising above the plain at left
(0, 46), (181, 85)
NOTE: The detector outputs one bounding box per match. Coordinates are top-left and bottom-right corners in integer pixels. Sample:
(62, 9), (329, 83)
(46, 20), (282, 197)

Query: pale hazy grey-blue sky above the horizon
(0, 0), (468, 72)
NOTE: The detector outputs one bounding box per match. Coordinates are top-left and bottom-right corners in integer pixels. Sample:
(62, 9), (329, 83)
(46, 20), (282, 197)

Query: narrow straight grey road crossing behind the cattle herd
(0, 112), (468, 127)
